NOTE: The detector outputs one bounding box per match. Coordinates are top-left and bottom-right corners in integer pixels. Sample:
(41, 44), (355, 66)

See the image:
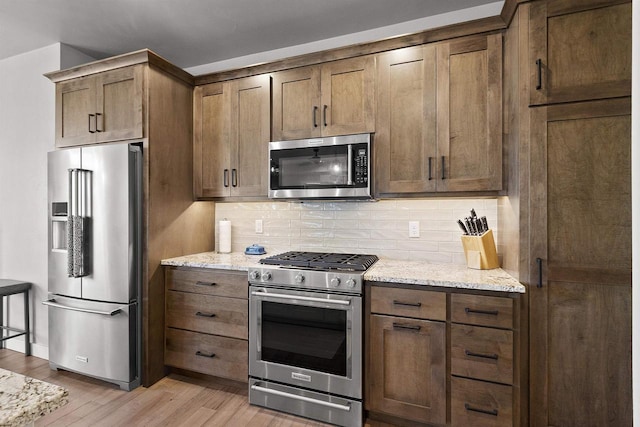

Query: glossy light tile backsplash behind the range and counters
(215, 198), (498, 264)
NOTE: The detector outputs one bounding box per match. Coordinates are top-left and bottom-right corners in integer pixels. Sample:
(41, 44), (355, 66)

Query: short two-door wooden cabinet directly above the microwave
(272, 56), (375, 141)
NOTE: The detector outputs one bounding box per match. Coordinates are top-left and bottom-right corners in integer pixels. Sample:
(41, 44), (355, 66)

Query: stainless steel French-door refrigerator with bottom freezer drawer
(43, 143), (142, 390)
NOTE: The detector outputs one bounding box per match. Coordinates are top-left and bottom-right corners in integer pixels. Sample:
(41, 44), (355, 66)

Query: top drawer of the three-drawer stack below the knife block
(451, 294), (513, 329)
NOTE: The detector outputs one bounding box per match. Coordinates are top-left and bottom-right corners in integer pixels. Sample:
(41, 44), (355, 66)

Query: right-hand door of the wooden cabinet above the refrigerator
(95, 65), (144, 142)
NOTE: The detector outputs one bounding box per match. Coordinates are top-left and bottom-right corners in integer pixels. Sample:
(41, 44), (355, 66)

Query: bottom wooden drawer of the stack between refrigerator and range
(164, 328), (249, 382)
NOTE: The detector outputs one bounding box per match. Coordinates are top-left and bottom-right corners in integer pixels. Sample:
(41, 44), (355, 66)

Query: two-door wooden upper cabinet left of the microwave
(193, 75), (271, 199)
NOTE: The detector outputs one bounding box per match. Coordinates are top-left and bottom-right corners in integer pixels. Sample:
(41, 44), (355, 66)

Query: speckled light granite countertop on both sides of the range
(162, 252), (526, 293)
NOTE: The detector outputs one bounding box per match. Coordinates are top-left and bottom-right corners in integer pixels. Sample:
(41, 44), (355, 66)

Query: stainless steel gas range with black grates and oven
(249, 252), (378, 426)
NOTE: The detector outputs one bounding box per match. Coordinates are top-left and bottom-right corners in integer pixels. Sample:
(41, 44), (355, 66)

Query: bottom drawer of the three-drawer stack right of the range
(451, 377), (513, 427)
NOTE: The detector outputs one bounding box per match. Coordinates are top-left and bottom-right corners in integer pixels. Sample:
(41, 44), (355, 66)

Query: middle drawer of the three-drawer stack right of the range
(451, 325), (513, 384)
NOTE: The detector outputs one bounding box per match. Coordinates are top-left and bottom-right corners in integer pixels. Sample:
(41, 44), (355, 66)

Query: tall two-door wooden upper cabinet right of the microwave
(374, 34), (502, 195)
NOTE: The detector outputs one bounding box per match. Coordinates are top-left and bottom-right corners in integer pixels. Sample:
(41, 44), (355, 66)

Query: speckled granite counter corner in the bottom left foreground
(0, 368), (69, 426)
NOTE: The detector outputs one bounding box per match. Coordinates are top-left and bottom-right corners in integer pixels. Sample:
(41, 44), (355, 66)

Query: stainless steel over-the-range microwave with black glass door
(269, 133), (373, 199)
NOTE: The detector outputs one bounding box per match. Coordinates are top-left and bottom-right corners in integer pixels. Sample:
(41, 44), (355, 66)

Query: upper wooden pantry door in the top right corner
(529, 0), (631, 105)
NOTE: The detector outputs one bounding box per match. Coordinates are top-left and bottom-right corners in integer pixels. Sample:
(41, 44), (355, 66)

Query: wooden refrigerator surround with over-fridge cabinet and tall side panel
(47, 49), (214, 386)
